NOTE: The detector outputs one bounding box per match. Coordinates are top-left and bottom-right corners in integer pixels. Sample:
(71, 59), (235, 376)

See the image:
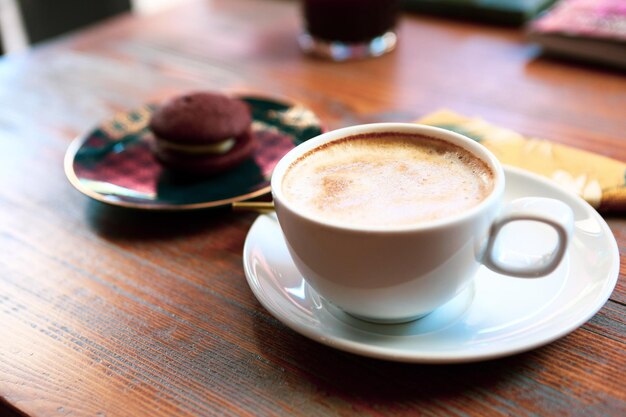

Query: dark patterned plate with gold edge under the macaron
(65, 96), (322, 210)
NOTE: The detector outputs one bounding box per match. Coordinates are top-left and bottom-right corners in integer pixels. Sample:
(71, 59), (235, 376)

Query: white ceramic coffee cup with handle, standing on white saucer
(271, 123), (573, 323)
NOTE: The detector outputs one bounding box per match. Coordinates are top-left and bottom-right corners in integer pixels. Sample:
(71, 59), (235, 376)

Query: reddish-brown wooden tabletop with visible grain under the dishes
(0, 0), (626, 417)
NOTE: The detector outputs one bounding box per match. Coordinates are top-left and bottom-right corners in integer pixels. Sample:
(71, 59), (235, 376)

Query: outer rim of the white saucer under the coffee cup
(243, 164), (620, 364)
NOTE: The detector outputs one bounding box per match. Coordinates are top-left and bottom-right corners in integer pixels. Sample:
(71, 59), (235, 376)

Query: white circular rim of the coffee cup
(270, 123), (505, 233)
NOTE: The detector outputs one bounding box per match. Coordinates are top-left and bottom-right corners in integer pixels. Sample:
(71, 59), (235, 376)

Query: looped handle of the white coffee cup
(483, 197), (574, 278)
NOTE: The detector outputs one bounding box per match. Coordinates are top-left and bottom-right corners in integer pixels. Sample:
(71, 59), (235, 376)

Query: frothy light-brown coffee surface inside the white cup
(281, 132), (494, 227)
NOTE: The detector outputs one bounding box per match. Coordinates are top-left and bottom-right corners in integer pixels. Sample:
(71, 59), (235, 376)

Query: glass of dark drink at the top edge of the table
(299, 0), (400, 61)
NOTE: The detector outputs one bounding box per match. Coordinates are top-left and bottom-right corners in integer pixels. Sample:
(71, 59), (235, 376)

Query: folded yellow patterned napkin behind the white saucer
(417, 110), (626, 212)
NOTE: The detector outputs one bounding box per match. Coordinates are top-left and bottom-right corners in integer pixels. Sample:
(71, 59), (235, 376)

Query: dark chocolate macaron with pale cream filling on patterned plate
(149, 92), (255, 175)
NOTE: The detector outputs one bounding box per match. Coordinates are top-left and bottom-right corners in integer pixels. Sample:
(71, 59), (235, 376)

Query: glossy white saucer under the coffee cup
(243, 167), (619, 363)
